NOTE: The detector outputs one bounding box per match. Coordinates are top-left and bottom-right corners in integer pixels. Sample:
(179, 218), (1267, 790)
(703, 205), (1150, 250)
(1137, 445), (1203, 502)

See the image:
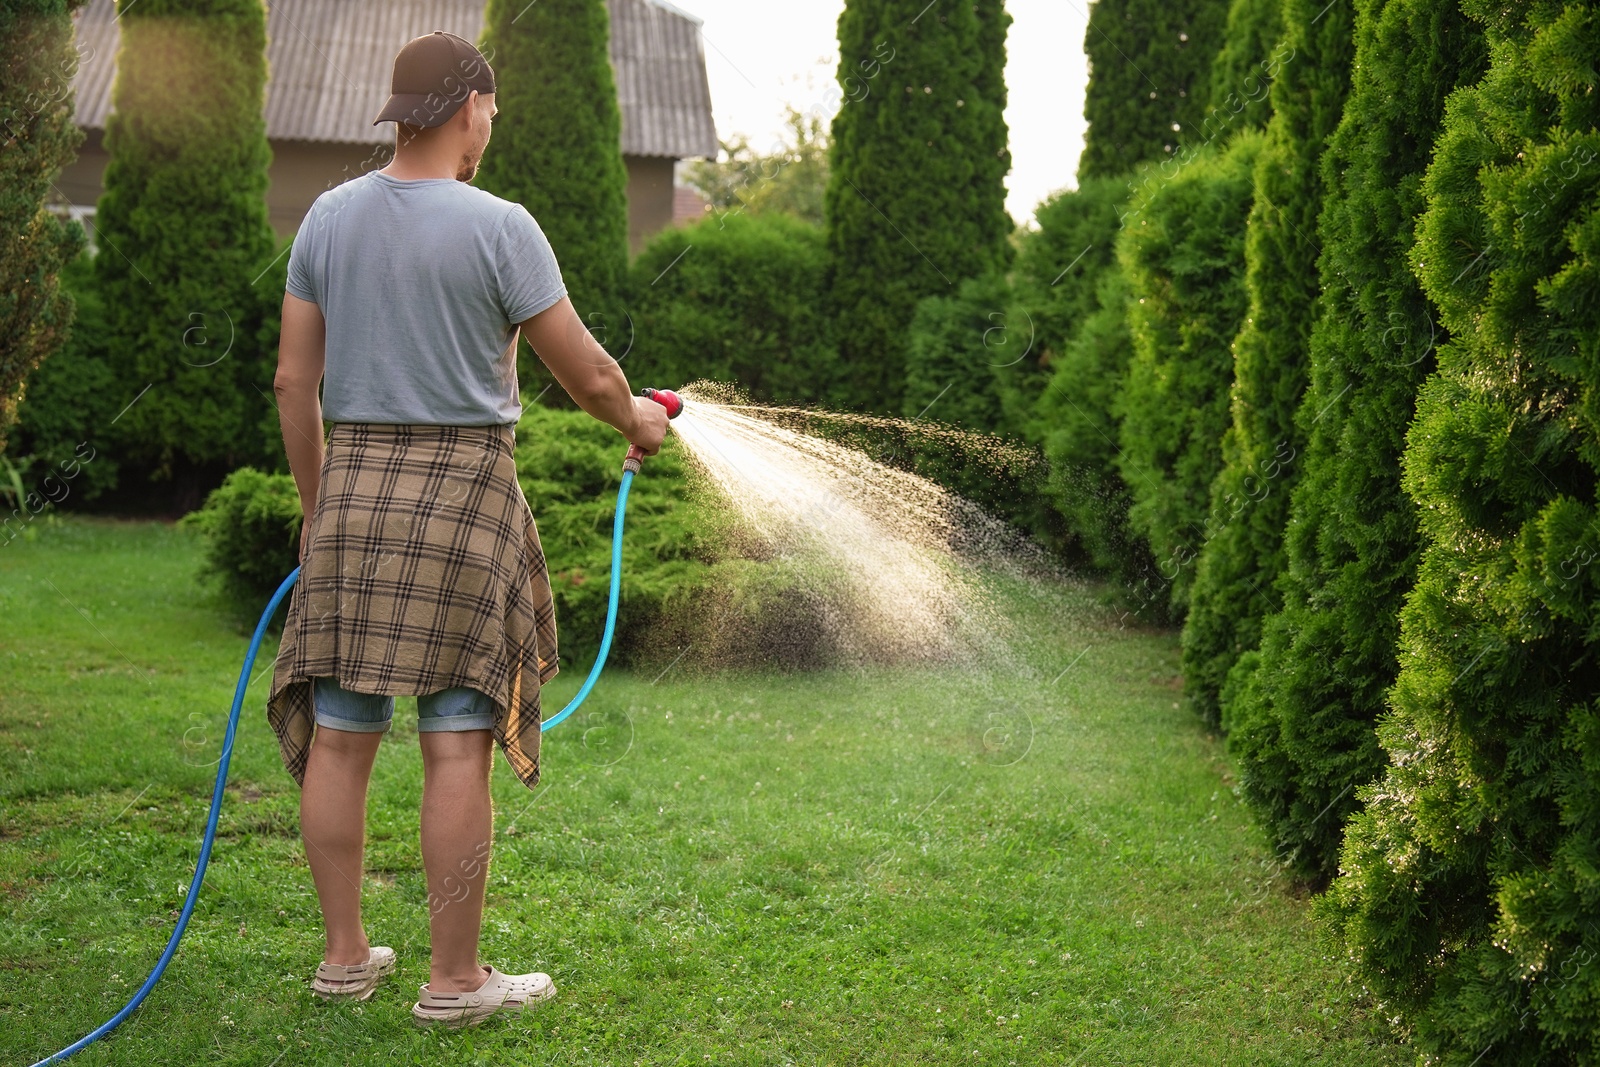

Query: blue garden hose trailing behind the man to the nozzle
(34, 467), (634, 1067)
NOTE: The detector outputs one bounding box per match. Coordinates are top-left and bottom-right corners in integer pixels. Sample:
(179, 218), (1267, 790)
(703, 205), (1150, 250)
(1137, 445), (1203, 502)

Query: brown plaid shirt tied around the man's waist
(267, 422), (557, 789)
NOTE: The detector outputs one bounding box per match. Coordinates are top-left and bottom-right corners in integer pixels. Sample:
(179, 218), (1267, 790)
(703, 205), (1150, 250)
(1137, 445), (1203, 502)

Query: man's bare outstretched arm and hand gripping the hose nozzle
(520, 296), (667, 456)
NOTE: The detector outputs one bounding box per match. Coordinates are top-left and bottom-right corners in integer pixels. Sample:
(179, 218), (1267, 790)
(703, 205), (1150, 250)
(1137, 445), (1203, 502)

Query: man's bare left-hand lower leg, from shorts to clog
(301, 726), (384, 966)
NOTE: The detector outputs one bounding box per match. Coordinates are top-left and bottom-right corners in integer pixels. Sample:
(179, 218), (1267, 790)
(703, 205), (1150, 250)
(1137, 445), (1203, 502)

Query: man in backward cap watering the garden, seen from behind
(267, 32), (667, 1025)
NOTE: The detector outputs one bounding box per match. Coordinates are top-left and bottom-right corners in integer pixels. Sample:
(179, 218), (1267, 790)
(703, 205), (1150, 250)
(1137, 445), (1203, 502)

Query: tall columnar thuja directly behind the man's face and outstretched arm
(472, 0), (629, 369)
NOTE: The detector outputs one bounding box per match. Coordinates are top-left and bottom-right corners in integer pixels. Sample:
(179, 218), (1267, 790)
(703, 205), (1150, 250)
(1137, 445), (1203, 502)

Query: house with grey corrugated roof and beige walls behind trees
(58, 0), (717, 251)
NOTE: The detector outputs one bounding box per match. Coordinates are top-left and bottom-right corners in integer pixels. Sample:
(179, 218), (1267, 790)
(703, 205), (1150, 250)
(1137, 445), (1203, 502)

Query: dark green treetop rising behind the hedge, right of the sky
(1078, 0), (1229, 179)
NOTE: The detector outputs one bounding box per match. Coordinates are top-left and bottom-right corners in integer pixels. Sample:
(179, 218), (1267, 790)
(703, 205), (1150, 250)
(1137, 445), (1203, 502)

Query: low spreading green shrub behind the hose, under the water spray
(517, 406), (896, 670)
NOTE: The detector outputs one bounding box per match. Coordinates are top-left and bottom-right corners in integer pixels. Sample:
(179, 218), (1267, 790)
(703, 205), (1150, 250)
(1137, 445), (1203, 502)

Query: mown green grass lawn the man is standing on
(0, 518), (1411, 1067)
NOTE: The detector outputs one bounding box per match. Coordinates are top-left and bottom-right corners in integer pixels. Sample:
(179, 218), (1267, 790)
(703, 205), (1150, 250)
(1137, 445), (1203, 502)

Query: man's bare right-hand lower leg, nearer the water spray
(418, 729), (494, 993)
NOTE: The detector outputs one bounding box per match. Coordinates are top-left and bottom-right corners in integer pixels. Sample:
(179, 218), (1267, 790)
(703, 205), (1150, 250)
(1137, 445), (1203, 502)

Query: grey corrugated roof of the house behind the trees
(74, 0), (717, 158)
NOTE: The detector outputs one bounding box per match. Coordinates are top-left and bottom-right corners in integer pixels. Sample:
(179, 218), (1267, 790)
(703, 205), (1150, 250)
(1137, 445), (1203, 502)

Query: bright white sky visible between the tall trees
(672, 0), (1088, 222)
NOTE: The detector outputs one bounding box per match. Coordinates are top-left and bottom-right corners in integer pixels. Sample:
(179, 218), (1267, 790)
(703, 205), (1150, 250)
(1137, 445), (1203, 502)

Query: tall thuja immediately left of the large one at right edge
(1226, 0), (1485, 883)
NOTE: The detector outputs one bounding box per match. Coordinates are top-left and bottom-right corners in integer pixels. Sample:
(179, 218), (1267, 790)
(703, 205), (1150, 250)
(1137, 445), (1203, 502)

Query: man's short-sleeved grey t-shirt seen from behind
(288, 171), (566, 426)
